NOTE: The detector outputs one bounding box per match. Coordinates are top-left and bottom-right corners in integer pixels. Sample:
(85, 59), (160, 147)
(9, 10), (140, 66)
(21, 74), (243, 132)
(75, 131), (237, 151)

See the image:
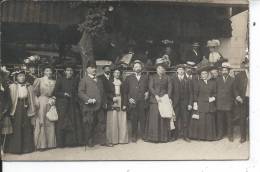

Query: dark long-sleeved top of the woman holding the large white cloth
(149, 74), (172, 103)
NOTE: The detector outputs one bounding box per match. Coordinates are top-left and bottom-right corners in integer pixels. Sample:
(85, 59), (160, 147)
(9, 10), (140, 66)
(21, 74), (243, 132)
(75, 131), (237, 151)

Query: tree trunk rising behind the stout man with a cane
(79, 32), (95, 74)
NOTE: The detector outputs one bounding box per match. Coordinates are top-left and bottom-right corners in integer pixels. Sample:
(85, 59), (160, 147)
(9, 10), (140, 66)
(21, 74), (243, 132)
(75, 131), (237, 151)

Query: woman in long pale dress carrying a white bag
(33, 66), (56, 150)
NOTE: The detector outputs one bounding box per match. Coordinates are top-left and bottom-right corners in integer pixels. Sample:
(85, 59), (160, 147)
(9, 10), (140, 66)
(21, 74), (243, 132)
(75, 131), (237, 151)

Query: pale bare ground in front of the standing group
(3, 137), (249, 161)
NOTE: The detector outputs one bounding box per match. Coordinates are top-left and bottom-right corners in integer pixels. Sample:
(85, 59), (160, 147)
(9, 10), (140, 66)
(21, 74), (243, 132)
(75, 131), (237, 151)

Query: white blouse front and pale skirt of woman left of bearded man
(106, 79), (128, 144)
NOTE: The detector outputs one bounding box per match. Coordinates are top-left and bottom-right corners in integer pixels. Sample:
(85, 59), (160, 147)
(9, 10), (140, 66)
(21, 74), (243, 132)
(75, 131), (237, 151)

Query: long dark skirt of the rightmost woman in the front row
(189, 113), (217, 141)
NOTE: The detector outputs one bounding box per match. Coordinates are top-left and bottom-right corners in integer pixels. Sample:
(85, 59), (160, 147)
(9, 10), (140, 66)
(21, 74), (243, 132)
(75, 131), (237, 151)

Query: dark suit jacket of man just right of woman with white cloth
(172, 74), (192, 108)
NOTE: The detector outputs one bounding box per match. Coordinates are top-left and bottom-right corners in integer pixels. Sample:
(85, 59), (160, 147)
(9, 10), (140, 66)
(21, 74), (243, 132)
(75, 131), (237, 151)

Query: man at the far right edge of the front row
(234, 59), (249, 143)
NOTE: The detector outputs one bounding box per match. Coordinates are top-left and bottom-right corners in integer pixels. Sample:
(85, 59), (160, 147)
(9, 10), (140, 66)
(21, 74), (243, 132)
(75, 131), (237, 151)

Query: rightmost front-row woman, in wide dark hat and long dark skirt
(189, 66), (216, 141)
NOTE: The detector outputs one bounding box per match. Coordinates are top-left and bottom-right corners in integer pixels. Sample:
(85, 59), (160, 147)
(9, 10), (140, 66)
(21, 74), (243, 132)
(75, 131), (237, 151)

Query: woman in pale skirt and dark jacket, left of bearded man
(106, 68), (128, 145)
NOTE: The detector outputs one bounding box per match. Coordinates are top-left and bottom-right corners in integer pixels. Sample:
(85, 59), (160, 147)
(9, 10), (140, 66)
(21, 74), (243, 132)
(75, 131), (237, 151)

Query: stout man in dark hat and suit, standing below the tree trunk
(78, 61), (106, 147)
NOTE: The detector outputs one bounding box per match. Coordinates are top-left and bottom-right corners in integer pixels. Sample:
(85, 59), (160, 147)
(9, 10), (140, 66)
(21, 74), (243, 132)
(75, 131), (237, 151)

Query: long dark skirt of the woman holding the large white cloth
(146, 104), (170, 142)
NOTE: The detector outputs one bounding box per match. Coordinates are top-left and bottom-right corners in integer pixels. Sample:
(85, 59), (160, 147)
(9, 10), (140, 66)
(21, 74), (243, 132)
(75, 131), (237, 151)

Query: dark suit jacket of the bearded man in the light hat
(123, 74), (148, 106)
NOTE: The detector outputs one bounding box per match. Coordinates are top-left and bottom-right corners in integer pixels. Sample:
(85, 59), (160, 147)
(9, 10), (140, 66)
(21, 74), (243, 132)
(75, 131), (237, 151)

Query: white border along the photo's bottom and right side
(3, 0), (260, 172)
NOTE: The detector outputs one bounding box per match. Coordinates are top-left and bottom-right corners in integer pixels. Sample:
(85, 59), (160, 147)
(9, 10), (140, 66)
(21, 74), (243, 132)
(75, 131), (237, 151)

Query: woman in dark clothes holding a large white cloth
(146, 60), (172, 142)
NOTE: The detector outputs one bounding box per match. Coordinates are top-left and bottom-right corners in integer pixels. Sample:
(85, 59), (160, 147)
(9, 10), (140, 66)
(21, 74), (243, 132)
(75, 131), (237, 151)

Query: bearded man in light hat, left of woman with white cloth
(123, 60), (148, 142)
